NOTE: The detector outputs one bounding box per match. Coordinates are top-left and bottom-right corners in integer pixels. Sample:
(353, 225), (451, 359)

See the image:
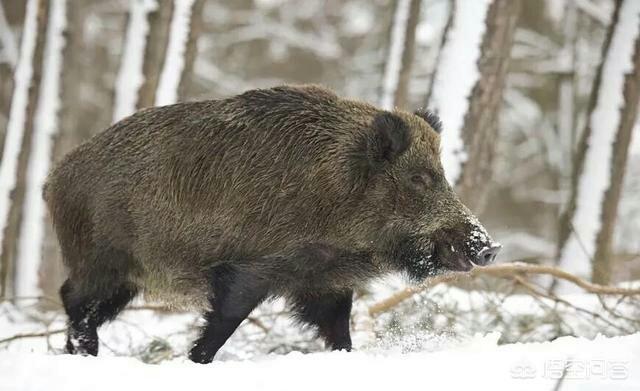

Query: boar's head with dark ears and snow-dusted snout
(344, 111), (500, 280)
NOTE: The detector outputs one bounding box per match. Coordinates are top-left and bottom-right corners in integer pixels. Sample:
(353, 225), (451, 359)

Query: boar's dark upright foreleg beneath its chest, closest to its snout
(294, 290), (353, 351)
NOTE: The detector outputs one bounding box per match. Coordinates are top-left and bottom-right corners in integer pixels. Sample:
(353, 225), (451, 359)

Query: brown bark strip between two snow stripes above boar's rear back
(137, 0), (173, 108)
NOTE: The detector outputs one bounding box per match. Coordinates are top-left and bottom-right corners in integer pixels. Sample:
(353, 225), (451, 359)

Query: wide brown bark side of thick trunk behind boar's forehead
(457, 0), (520, 213)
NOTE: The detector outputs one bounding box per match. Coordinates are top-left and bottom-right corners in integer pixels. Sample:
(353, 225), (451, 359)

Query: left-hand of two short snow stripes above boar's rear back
(113, 0), (158, 122)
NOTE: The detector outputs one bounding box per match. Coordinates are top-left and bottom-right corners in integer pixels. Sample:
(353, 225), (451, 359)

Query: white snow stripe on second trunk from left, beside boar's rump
(15, 0), (66, 296)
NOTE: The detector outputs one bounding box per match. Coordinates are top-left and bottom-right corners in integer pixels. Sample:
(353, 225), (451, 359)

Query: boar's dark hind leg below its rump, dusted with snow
(60, 280), (137, 356)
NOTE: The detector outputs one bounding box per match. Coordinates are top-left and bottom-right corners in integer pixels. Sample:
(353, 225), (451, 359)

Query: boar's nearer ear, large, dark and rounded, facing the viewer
(367, 112), (411, 164)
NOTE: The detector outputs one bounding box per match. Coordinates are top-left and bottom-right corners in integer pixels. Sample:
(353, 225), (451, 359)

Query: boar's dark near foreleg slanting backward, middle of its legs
(189, 265), (269, 364)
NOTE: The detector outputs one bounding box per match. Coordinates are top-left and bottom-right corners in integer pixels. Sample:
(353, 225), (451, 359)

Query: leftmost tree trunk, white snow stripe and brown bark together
(0, 0), (48, 294)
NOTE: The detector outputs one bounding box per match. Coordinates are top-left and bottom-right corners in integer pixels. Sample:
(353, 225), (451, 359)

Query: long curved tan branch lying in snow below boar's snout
(369, 262), (640, 316)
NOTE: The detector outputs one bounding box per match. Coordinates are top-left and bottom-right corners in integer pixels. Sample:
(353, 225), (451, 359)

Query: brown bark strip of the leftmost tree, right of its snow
(0, 0), (49, 296)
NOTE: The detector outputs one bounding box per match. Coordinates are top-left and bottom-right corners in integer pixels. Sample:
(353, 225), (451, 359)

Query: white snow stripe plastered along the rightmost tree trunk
(560, 0), (640, 284)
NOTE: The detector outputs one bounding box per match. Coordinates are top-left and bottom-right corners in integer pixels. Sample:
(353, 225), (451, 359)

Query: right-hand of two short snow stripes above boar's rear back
(156, 0), (194, 106)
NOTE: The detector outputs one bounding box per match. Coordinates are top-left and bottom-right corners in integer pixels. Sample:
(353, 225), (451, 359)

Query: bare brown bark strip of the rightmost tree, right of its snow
(591, 24), (640, 284)
